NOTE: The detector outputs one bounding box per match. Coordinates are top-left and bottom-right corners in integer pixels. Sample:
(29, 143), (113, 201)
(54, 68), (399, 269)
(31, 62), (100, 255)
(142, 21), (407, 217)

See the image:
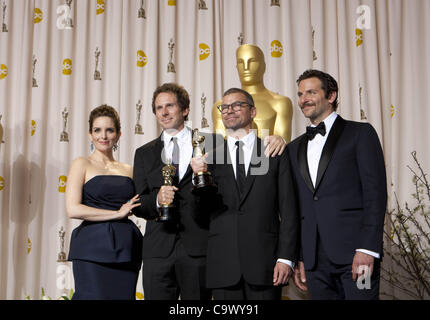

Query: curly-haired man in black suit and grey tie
(133, 83), (211, 300)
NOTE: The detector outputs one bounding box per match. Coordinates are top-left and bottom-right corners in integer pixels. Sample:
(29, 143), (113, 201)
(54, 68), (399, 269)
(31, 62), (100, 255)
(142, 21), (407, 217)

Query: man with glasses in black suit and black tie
(191, 88), (299, 300)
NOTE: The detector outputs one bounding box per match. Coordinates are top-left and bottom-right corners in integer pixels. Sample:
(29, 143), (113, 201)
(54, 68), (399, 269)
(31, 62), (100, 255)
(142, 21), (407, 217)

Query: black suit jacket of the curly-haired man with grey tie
(133, 133), (220, 259)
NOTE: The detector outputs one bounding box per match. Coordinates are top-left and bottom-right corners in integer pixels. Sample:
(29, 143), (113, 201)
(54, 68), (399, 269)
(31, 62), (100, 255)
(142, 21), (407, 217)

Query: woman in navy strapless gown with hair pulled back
(66, 105), (142, 300)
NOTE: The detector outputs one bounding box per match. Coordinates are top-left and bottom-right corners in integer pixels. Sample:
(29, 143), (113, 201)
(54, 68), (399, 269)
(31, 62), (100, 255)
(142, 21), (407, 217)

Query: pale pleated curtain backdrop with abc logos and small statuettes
(0, 0), (430, 299)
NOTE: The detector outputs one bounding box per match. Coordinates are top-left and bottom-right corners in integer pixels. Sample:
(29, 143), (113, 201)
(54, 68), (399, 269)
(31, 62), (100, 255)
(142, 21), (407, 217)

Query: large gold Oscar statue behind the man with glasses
(212, 44), (293, 143)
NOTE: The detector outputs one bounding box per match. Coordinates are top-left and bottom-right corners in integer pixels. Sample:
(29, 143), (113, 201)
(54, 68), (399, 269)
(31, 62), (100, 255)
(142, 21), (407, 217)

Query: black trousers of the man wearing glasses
(212, 277), (282, 300)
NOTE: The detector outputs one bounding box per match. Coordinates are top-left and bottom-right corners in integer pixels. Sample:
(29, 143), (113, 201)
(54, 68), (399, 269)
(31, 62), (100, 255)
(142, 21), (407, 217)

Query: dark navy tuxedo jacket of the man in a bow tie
(287, 115), (387, 270)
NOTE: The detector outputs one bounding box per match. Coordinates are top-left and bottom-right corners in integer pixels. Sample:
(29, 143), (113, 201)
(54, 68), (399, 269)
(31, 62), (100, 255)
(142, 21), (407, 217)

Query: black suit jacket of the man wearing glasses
(199, 138), (299, 288)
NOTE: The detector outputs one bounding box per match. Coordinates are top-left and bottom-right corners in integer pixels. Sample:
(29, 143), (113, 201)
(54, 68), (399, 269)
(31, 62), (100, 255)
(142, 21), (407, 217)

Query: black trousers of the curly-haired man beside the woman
(143, 239), (212, 300)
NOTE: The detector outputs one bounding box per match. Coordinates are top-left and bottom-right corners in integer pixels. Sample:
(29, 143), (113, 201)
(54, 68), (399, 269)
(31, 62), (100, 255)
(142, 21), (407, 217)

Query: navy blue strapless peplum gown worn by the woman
(69, 175), (142, 300)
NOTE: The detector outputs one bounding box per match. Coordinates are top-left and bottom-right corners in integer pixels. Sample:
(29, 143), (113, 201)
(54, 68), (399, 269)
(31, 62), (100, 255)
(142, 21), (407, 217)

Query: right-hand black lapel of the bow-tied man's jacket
(315, 115), (346, 190)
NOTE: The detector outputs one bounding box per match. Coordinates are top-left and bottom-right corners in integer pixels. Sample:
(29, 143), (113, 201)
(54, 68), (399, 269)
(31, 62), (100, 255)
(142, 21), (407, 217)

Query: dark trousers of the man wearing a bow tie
(306, 237), (381, 300)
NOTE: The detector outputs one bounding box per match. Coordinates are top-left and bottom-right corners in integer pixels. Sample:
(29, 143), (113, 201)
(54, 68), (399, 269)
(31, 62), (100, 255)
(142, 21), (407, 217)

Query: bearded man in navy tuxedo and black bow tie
(287, 70), (387, 299)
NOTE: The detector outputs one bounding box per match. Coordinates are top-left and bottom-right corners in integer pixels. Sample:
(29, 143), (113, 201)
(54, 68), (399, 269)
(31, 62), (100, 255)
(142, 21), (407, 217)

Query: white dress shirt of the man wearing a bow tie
(307, 111), (380, 259)
